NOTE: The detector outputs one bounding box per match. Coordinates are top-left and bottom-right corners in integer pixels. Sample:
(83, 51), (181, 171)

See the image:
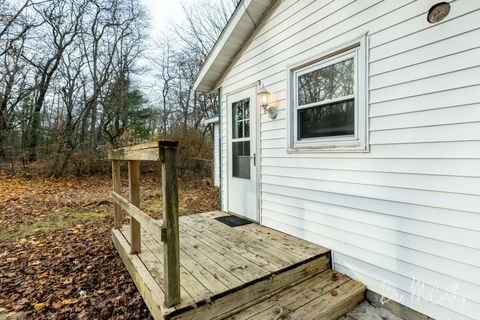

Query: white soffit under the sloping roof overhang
(193, 0), (275, 92)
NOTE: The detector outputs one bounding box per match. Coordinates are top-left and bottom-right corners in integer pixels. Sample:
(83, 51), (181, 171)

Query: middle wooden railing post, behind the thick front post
(128, 160), (141, 254)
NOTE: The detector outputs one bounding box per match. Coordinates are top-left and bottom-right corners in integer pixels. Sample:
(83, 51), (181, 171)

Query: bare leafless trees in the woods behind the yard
(0, 0), (237, 176)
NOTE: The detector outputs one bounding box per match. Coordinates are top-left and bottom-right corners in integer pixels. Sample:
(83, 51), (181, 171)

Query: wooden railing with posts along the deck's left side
(108, 141), (180, 307)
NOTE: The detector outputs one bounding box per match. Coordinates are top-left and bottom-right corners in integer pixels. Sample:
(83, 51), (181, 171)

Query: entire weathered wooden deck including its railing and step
(109, 141), (365, 320)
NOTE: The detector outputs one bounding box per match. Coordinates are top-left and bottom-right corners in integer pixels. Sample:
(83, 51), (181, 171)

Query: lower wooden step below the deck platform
(226, 270), (365, 320)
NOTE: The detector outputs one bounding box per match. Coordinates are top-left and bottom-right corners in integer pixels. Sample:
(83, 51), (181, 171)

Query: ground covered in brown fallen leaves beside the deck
(0, 173), (218, 319)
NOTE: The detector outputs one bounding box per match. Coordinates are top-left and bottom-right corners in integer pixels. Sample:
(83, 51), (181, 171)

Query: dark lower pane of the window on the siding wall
(298, 99), (355, 139)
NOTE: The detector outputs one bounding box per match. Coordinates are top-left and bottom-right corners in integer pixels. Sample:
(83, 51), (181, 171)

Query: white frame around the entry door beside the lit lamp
(225, 81), (262, 224)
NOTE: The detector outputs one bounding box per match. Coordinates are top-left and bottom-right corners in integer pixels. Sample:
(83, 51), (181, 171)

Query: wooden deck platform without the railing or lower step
(112, 212), (356, 319)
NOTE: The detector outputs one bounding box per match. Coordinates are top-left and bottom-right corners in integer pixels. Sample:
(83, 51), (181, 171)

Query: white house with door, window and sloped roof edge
(195, 0), (480, 320)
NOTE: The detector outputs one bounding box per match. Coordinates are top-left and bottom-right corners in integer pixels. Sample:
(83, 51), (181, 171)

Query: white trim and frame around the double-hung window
(287, 34), (369, 153)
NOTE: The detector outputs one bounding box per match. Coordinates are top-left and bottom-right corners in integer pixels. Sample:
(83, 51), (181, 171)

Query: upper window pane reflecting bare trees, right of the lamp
(298, 58), (354, 106)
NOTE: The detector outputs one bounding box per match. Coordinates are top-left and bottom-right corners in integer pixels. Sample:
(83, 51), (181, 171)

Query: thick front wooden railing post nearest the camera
(158, 141), (180, 308)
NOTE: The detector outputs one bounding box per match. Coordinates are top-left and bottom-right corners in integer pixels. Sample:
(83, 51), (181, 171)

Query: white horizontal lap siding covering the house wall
(220, 0), (480, 319)
